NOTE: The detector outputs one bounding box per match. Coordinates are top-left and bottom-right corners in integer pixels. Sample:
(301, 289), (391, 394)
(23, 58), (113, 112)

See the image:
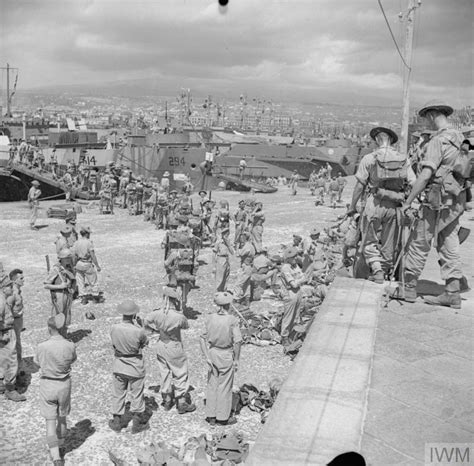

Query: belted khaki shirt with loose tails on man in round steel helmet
(110, 322), (148, 378)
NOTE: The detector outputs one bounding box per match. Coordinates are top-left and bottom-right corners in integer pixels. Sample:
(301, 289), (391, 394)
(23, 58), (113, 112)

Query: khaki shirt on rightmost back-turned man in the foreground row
(202, 312), (242, 349)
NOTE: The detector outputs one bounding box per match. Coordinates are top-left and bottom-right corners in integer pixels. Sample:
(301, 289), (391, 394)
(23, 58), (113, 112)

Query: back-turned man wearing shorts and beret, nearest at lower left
(34, 314), (77, 466)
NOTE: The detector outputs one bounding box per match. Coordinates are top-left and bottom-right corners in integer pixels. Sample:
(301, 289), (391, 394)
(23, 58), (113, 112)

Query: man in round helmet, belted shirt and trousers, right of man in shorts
(109, 300), (150, 434)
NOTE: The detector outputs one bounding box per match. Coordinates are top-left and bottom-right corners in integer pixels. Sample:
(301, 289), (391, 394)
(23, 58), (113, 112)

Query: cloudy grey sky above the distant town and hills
(0, 0), (474, 107)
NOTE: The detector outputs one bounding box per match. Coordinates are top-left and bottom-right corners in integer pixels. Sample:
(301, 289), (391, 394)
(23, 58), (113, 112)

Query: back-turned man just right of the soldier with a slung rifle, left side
(73, 227), (104, 304)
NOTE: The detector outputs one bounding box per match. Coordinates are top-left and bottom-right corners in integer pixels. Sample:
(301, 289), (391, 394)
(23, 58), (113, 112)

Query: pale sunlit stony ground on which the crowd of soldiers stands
(0, 183), (351, 465)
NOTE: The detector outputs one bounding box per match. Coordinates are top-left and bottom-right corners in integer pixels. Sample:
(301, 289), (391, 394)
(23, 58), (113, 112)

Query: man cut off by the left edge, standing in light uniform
(0, 275), (26, 401)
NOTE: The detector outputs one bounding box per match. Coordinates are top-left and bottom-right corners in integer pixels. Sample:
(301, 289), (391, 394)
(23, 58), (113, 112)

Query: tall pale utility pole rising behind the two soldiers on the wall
(399, 0), (421, 154)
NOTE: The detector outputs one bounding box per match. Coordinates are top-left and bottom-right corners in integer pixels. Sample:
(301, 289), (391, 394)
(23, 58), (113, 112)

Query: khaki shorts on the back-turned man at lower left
(40, 378), (71, 419)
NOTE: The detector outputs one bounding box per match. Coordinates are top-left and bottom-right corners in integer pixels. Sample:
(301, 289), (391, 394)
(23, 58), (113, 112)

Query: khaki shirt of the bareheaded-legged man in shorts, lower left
(34, 335), (77, 379)
